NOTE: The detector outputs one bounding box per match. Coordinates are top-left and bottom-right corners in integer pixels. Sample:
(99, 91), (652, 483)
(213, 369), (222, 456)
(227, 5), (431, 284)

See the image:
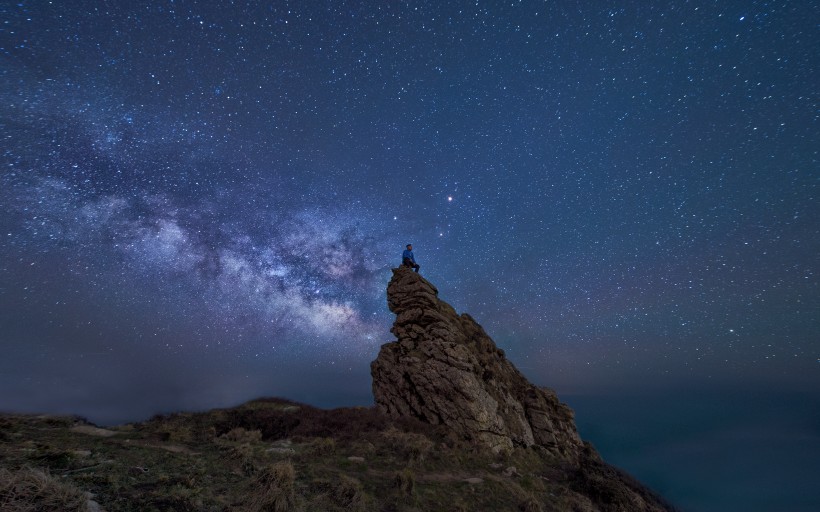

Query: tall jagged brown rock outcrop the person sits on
(370, 267), (583, 461)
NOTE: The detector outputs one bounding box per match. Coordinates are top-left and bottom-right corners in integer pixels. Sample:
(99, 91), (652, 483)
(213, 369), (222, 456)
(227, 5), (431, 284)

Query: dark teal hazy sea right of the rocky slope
(559, 390), (820, 512)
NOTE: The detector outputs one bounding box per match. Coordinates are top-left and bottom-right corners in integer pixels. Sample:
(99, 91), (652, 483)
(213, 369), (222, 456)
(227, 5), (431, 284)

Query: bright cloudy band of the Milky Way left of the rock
(18, 175), (388, 340)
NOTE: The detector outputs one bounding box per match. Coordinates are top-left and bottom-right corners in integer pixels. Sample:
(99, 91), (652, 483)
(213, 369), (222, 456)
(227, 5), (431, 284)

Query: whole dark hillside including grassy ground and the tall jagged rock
(0, 269), (673, 512)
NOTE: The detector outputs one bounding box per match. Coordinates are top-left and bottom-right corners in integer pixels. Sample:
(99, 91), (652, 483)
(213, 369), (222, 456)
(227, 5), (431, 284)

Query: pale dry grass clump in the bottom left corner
(0, 468), (89, 512)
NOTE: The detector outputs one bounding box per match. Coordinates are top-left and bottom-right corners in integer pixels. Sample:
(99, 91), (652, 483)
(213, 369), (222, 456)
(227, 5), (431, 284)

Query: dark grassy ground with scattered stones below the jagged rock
(0, 399), (680, 512)
